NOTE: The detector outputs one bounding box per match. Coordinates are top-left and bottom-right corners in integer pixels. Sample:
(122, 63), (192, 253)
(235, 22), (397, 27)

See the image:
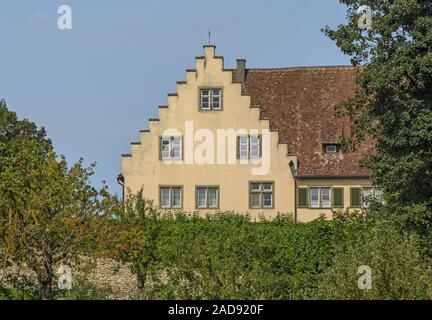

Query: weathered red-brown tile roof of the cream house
(240, 66), (373, 177)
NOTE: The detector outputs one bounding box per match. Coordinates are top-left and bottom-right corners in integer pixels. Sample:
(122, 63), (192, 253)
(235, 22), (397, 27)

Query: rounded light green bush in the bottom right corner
(316, 221), (432, 300)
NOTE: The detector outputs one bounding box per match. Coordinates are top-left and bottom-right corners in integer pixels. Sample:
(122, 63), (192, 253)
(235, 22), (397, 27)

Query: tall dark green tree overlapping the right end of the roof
(323, 0), (432, 210)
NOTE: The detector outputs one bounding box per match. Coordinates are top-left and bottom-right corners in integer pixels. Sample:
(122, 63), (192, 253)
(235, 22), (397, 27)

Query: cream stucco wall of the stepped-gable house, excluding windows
(122, 46), (369, 221)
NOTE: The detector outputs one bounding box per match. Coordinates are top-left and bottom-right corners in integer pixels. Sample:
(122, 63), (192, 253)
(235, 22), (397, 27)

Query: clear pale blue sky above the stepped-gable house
(0, 0), (349, 193)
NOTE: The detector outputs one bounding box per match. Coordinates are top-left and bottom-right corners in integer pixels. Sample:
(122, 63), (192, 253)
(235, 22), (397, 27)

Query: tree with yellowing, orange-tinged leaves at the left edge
(0, 102), (114, 299)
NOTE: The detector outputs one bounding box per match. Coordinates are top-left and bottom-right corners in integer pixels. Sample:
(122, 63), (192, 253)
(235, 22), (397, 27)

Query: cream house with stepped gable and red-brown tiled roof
(120, 45), (381, 221)
